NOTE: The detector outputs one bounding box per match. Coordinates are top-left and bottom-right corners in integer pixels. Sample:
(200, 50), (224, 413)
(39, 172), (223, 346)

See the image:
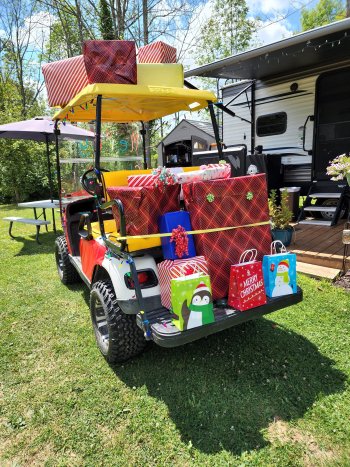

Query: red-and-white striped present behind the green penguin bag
(158, 256), (208, 309)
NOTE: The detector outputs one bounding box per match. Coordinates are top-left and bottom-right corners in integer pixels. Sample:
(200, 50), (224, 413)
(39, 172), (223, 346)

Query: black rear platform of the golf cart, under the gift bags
(137, 287), (303, 347)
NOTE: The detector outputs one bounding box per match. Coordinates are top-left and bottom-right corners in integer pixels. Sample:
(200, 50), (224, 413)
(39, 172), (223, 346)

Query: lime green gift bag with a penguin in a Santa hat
(171, 273), (215, 331)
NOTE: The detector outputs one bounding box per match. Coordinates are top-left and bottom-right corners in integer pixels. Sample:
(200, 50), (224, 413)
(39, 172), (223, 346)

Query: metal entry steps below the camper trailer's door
(298, 181), (348, 227)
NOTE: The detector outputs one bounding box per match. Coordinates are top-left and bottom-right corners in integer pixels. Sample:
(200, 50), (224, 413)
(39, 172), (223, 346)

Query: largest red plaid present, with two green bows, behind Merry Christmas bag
(183, 174), (271, 299)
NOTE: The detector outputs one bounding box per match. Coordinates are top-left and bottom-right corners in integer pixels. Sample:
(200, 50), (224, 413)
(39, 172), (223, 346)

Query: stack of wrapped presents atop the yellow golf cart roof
(42, 40), (180, 107)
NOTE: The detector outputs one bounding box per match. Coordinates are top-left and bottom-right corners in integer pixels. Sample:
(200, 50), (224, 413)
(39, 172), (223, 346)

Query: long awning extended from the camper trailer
(185, 18), (350, 80)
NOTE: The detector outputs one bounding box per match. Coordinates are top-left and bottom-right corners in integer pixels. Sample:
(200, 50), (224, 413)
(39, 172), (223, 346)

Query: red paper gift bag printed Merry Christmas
(228, 249), (266, 311)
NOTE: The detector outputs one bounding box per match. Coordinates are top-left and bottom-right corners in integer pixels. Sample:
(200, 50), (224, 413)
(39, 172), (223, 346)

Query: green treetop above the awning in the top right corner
(300, 0), (345, 31)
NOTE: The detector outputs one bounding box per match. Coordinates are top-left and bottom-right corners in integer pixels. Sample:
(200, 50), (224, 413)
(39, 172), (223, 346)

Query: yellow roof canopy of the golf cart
(53, 83), (217, 123)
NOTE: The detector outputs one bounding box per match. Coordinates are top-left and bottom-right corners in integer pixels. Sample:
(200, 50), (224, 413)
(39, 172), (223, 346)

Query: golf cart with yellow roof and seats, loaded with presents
(54, 80), (302, 363)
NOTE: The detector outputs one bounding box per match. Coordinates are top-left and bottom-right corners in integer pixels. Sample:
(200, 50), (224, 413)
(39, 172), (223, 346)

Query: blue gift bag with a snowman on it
(263, 240), (297, 297)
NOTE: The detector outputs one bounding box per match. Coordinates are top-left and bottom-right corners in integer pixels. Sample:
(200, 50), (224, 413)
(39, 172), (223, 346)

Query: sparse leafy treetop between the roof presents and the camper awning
(197, 0), (255, 64)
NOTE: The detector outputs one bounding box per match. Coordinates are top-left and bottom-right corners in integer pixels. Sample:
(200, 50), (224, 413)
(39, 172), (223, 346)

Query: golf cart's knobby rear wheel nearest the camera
(90, 280), (146, 363)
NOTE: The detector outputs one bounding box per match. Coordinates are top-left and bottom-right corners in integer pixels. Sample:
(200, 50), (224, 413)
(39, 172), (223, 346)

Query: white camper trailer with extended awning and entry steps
(185, 19), (350, 226)
